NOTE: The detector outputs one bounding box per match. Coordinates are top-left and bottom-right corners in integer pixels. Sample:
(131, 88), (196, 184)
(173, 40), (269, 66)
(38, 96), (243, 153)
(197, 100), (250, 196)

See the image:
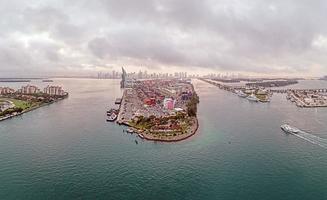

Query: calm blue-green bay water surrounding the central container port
(0, 79), (327, 200)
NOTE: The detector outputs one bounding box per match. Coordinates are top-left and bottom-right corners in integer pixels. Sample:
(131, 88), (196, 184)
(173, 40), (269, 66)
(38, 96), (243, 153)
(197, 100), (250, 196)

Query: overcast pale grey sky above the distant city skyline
(0, 0), (327, 77)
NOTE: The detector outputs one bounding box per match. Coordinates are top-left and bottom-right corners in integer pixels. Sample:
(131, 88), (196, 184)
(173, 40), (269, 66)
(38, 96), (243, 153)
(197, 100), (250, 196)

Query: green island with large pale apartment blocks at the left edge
(0, 85), (68, 121)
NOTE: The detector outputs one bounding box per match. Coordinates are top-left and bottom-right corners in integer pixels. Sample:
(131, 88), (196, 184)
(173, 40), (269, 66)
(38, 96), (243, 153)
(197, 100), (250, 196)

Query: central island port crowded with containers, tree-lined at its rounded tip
(117, 79), (199, 142)
